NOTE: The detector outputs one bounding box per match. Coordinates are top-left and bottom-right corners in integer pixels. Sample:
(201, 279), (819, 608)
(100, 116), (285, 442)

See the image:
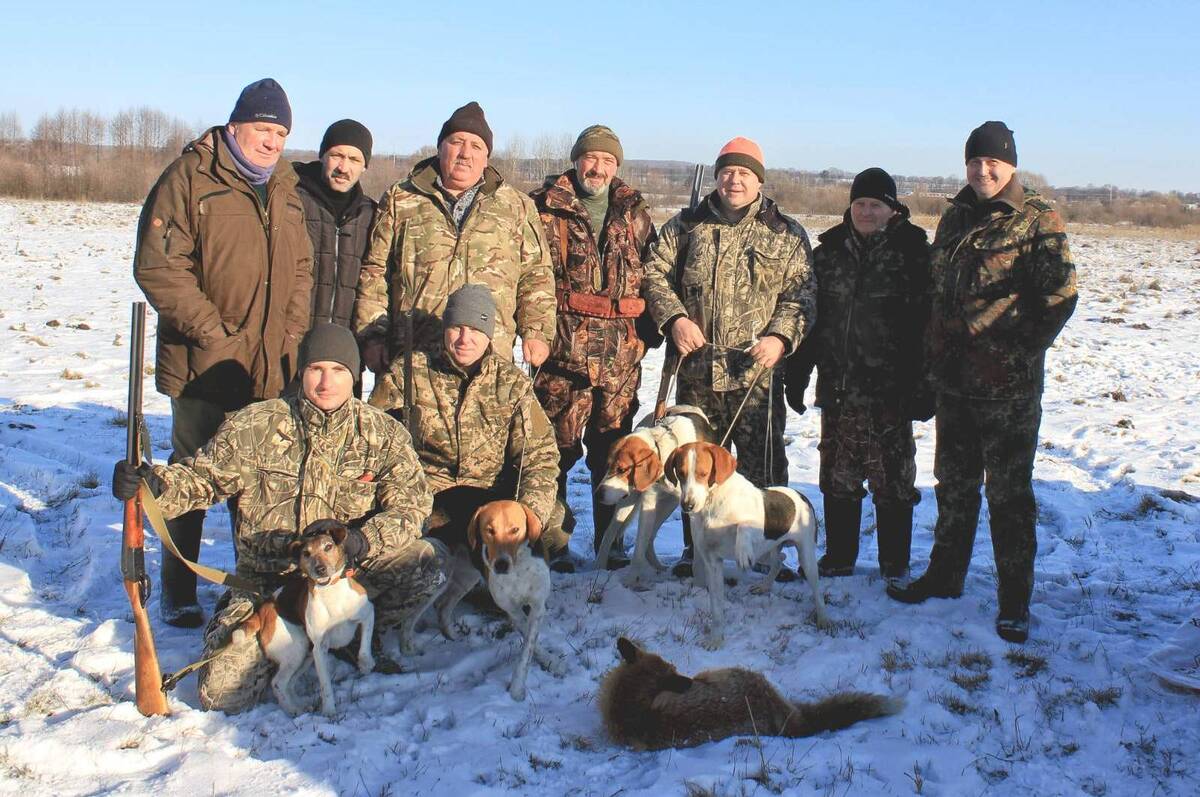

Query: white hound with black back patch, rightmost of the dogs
(665, 443), (829, 651)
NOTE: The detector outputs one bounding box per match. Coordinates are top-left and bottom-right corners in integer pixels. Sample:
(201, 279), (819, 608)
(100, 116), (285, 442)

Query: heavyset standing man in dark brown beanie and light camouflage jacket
(354, 102), (557, 373)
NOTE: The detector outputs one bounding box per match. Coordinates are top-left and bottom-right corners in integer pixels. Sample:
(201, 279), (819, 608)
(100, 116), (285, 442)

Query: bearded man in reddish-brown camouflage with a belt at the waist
(530, 125), (654, 573)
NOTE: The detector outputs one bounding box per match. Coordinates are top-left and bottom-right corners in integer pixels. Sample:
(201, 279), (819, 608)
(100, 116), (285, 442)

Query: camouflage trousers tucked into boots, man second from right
(817, 400), (920, 507)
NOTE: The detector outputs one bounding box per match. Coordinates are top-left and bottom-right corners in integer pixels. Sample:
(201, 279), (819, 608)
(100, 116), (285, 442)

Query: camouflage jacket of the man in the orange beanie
(642, 192), (816, 391)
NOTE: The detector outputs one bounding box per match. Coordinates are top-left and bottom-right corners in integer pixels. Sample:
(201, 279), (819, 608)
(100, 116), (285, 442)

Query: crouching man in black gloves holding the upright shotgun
(113, 323), (445, 713)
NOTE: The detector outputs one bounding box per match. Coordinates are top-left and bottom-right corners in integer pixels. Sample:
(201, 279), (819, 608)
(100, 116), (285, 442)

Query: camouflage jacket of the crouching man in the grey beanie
(370, 348), (558, 523)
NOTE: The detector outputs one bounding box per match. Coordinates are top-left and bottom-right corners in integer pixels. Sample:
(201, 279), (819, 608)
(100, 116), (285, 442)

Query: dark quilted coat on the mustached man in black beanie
(295, 161), (376, 326)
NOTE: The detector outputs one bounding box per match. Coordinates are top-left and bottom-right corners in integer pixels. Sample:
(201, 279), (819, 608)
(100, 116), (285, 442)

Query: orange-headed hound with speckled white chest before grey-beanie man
(409, 487), (554, 701)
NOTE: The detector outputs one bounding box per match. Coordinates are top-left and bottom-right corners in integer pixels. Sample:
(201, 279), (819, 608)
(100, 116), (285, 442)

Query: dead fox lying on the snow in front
(600, 636), (904, 750)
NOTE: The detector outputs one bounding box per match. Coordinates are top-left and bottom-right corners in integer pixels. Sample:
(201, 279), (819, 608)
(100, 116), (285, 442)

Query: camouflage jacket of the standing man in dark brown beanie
(354, 157), (554, 360)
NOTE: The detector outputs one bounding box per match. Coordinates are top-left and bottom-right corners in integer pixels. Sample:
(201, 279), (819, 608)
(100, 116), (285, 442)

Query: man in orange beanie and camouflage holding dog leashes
(642, 138), (816, 574)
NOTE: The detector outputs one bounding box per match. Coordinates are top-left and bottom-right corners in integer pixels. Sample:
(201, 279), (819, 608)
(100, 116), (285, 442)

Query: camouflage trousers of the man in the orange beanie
(676, 367), (787, 487)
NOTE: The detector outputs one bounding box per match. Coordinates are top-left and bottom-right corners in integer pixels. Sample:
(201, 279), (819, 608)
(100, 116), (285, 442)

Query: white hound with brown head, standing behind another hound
(595, 405), (716, 588)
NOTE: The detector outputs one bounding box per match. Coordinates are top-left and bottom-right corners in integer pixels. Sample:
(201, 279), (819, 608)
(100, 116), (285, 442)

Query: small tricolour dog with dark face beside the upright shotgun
(232, 520), (374, 717)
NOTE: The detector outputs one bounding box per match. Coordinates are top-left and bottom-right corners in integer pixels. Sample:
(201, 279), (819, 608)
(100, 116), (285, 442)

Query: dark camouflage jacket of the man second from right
(786, 205), (930, 407)
